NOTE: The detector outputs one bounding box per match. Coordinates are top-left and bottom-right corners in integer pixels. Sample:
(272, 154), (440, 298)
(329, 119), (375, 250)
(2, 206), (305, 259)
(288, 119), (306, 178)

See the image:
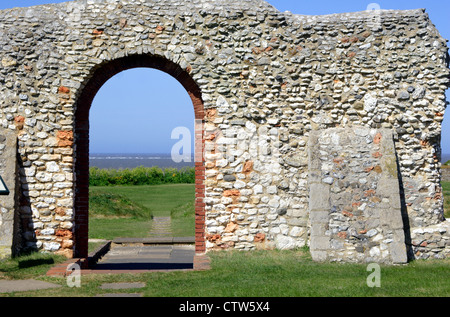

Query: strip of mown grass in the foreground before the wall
(0, 250), (450, 297)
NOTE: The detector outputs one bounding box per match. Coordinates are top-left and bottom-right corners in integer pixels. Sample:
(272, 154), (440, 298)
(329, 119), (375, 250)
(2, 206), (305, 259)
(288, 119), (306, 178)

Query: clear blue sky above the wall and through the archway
(0, 0), (450, 154)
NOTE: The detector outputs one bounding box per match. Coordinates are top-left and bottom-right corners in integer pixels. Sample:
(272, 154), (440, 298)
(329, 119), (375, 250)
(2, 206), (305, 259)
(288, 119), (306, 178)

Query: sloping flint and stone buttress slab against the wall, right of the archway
(308, 127), (407, 263)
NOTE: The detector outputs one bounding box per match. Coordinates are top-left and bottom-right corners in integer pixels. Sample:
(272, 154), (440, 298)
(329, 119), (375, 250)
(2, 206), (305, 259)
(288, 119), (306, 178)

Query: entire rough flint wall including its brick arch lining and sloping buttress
(0, 0), (450, 263)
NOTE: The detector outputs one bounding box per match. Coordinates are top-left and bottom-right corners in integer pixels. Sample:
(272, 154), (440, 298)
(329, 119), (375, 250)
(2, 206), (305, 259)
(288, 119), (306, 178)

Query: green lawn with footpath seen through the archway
(89, 184), (195, 250)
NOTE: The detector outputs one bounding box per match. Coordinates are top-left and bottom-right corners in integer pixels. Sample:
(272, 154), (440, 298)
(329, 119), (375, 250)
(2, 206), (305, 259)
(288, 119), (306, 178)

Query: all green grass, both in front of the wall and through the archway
(0, 183), (450, 297)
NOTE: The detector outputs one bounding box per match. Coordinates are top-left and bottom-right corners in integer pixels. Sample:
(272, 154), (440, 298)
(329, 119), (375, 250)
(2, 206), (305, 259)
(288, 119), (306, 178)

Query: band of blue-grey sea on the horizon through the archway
(89, 153), (195, 169)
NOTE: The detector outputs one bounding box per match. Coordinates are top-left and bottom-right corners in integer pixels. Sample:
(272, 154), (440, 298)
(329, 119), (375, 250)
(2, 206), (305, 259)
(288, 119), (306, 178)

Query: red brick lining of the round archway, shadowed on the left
(74, 55), (205, 258)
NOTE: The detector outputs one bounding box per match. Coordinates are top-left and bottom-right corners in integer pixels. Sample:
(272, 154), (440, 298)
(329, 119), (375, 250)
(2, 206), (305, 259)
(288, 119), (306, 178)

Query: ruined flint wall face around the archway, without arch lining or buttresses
(0, 0), (449, 257)
